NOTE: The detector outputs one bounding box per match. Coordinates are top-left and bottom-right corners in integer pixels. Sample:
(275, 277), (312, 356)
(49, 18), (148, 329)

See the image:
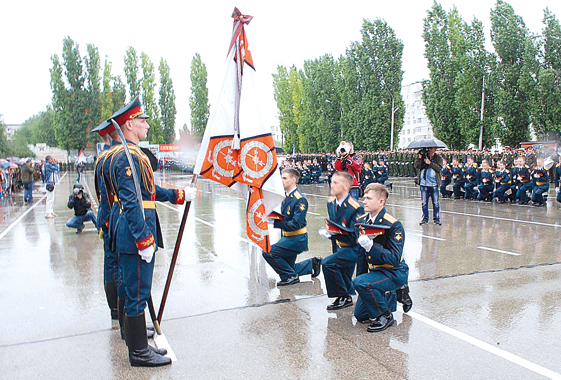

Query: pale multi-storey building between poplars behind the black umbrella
(397, 82), (434, 149)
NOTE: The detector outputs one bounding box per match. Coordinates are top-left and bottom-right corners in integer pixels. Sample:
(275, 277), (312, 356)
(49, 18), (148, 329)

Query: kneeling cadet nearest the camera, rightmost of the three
(353, 184), (413, 332)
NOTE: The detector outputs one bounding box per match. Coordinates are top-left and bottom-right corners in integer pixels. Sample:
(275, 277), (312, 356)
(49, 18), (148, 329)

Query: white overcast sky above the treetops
(0, 0), (561, 134)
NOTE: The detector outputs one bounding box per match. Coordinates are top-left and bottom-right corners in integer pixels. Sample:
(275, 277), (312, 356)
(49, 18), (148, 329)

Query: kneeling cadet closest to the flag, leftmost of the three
(263, 168), (321, 286)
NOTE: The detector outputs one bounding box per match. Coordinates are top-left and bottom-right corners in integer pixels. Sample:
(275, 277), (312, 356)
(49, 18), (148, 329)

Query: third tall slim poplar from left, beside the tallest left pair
(84, 44), (103, 143)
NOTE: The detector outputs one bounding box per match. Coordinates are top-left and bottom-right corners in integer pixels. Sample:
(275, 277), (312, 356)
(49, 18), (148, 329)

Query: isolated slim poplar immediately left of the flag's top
(189, 53), (210, 138)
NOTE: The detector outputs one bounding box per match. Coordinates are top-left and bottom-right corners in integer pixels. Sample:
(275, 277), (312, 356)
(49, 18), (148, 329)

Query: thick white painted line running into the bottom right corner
(407, 311), (561, 379)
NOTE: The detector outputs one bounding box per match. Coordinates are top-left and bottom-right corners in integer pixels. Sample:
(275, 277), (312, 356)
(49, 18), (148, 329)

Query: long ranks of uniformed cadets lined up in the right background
(281, 146), (561, 206)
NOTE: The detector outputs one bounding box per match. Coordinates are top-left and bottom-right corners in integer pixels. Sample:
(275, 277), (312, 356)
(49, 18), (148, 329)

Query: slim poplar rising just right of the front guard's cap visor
(140, 52), (165, 144)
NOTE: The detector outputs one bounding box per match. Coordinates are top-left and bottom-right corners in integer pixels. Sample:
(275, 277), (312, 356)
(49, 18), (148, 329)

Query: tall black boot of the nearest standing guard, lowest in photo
(125, 313), (171, 367)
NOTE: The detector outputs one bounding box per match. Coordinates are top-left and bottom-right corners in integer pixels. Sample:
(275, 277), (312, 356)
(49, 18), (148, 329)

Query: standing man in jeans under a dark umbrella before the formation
(413, 147), (442, 225)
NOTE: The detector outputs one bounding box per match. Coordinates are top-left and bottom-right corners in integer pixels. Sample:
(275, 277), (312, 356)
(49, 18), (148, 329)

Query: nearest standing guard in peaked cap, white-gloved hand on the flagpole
(109, 97), (195, 367)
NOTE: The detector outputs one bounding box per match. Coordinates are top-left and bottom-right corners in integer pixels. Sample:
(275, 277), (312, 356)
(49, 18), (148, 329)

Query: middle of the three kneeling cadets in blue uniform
(319, 172), (364, 310)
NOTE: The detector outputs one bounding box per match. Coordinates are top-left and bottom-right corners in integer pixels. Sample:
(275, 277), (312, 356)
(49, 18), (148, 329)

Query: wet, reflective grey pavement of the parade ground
(0, 172), (561, 379)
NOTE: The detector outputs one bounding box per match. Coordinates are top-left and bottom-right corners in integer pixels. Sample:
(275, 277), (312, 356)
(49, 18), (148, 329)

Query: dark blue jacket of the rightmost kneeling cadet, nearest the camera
(357, 208), (409, 284)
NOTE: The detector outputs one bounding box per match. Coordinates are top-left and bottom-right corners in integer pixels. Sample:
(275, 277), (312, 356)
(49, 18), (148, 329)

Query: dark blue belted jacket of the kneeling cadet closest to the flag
(274, 188), (308, 253)
